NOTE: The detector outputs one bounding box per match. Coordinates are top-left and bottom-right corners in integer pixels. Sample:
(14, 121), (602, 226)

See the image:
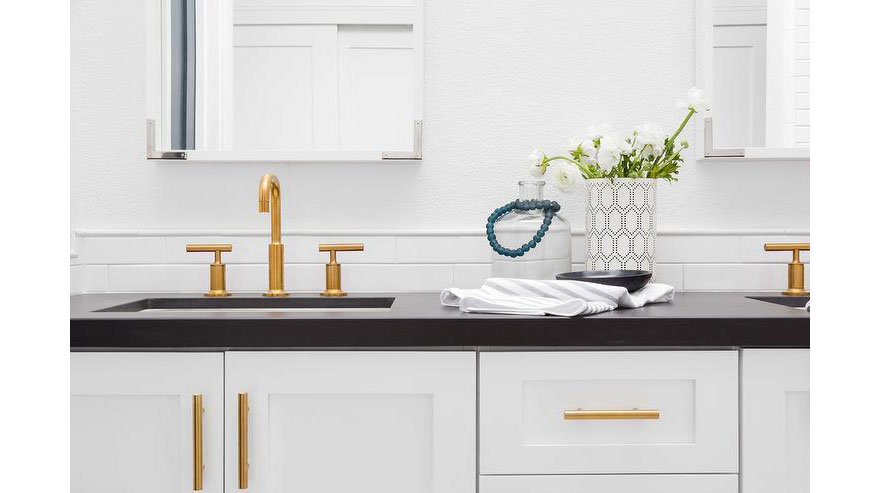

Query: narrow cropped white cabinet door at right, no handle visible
(742, 349), (810, 493)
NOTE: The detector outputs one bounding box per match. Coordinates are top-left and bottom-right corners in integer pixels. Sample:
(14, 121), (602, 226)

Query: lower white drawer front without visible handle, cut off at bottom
(480, 474), (738, 493)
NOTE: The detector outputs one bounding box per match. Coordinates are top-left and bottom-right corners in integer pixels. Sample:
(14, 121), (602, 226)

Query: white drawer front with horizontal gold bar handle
(480, 351), (738, 474)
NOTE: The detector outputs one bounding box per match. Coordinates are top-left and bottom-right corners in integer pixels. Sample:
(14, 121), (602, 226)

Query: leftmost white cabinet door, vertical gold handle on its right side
(70, 353), (223, 493)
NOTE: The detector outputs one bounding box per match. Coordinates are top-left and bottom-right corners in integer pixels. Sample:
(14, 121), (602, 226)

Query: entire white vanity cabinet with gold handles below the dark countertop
(71, 349), (809, 493)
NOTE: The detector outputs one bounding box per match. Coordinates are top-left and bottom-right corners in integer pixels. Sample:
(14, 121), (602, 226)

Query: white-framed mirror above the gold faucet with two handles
(146, 0), (424, 162)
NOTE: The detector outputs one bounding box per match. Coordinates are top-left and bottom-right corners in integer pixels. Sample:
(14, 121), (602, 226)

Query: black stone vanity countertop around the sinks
(70, 292), (810, 351)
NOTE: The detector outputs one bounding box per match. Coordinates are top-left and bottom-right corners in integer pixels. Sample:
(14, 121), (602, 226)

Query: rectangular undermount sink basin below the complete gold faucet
(95, 296), (394, 313)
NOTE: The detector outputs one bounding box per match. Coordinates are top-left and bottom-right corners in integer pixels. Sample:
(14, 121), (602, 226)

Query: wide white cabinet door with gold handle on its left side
(226, 350), (476, 493)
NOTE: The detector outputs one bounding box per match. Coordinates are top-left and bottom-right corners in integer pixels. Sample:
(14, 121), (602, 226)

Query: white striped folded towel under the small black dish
(440, 278), (675, 317)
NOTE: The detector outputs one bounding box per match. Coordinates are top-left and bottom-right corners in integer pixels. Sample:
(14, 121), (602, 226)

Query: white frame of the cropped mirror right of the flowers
(694, 0), (810, 162)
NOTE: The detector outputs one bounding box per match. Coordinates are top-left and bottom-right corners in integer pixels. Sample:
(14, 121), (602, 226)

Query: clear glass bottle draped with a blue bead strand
(491, 180), (571, 279)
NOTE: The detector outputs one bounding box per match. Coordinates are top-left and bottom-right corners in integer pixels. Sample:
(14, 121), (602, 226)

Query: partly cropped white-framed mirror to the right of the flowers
(695, 0), (810, 160)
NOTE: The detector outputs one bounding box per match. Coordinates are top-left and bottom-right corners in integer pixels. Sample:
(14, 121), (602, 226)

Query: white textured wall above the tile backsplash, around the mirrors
(71, 0), (809, 231)
